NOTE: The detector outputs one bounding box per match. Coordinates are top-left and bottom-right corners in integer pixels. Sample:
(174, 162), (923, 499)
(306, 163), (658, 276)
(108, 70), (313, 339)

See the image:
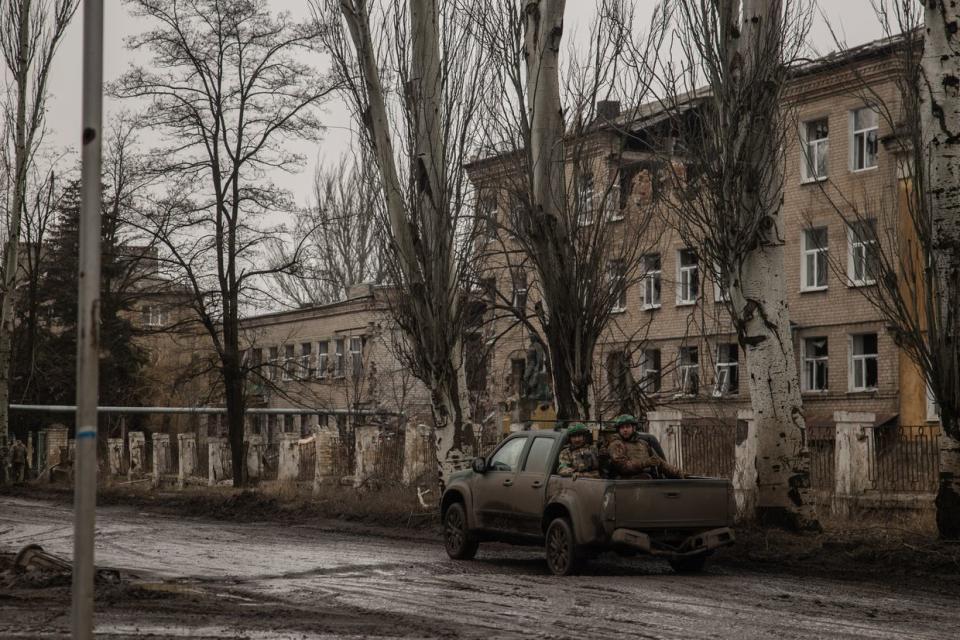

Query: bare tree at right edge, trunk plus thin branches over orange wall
(821, 0), (960, 540)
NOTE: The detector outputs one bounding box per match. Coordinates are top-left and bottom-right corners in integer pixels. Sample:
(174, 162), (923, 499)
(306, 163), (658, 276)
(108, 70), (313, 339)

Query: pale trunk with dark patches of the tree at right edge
(920, 0), (960, 540)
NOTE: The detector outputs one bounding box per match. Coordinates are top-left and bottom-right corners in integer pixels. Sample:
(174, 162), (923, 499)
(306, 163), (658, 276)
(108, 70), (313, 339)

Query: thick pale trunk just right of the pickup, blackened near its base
(721, 0), (816, 529)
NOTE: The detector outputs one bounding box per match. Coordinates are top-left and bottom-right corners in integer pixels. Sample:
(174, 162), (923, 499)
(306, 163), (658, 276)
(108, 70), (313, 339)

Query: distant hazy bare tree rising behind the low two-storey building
(274, 156), (385, 306)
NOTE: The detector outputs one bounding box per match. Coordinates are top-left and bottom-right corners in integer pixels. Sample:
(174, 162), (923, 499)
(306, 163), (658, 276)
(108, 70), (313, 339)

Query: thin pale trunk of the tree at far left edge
(0, 0), (32, 439)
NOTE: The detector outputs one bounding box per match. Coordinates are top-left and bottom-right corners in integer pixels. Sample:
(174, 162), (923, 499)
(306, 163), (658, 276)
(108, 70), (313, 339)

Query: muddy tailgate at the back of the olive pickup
(612, 478), (735, 529)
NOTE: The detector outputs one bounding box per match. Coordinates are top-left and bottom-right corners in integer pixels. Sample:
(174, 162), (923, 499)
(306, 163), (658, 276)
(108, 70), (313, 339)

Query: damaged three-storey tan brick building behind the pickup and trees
(470, 36), (936, 436)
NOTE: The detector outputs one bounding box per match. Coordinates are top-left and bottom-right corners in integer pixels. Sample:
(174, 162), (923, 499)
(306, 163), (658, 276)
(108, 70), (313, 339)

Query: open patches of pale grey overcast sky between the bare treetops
(48, 0), (881, 205)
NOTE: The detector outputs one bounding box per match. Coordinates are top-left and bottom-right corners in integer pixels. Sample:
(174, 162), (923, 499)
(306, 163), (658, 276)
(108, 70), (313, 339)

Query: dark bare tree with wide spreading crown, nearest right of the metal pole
(110, 0), (332, 486)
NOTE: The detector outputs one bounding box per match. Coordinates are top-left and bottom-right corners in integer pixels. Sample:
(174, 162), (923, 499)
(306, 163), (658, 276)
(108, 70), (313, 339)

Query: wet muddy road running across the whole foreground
(0, 497), (960, 640)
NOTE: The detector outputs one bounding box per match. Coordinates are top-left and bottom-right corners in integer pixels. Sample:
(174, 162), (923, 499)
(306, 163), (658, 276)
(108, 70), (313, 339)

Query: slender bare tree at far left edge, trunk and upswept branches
(0, 0), (79, 442)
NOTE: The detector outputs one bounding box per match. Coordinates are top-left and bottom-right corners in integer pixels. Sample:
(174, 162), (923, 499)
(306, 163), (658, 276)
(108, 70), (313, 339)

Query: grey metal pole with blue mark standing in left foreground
(71, 0), (103, 640)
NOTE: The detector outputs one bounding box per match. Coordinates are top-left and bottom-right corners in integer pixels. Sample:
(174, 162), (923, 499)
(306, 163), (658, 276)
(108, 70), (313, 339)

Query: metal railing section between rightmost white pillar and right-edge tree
(868, 425), (940, 493)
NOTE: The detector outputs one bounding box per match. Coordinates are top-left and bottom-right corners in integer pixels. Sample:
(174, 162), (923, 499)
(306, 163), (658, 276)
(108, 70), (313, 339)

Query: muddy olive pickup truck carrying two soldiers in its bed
(440, 431), (736, 575)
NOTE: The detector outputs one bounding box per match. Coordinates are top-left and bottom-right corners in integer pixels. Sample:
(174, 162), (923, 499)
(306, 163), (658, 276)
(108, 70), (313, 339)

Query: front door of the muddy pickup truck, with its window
(473, 434), (529, 531)
